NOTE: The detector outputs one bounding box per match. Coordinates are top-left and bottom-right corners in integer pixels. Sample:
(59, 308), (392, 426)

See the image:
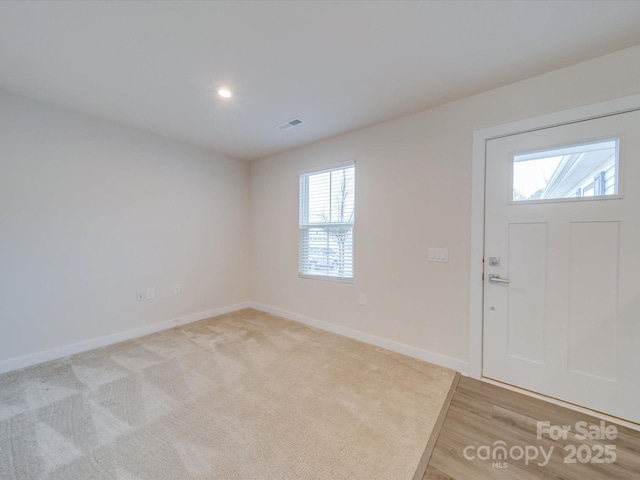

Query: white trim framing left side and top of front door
(469, 94), (640, 379)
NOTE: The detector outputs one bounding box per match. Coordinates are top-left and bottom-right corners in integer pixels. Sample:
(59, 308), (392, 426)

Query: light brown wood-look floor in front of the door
(422, 377), (640, 480)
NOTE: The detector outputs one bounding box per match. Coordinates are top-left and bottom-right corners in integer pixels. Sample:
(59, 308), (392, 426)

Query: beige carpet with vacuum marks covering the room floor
(0, 309), (454, 480)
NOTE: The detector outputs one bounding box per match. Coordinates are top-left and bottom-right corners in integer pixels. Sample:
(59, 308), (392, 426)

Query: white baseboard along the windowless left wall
(0, 302), (251, 373)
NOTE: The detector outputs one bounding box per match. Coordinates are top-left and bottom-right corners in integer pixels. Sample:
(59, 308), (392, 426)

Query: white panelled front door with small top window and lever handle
(482, 111), (640, 423)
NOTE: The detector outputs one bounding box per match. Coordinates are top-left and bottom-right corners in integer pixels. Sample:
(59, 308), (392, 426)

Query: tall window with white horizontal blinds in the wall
(299, 164), (355, 279)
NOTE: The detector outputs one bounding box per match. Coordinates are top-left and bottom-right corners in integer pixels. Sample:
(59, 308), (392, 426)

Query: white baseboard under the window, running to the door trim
(251, 302), (469, 375)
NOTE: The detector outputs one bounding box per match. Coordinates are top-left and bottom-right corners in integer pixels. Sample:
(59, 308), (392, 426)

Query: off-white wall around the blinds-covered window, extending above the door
(251, 46), (640, 371)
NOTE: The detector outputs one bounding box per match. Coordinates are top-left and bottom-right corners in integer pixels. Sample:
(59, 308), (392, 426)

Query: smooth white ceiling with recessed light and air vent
(0, 0), (640, 160)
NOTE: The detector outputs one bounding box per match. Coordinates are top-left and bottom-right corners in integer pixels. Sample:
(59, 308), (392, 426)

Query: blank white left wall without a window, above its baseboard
(0, 93), (250, 367)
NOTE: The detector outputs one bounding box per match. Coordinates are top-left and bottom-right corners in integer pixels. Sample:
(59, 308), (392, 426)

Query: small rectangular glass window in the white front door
(513, 139), (619, 202)
